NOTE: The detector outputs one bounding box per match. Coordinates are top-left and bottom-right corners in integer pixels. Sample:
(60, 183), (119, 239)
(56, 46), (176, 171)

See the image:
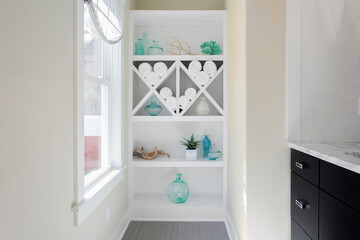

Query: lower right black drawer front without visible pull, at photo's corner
(319, 190), (360, 240)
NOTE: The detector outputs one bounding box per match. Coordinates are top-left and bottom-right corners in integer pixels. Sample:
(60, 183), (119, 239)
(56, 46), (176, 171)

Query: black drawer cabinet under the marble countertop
(291, 150), (360, 240)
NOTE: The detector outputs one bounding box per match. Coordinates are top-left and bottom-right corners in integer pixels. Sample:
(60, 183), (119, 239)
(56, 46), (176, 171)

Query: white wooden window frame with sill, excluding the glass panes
(72, 0), (124, 226)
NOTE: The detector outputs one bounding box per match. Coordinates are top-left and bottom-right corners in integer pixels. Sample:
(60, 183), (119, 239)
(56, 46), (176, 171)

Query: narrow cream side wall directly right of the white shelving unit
(226, 0), (247, 240)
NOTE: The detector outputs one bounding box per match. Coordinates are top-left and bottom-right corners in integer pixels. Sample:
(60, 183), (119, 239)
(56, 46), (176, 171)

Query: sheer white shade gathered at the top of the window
(85, 0), (123, 44)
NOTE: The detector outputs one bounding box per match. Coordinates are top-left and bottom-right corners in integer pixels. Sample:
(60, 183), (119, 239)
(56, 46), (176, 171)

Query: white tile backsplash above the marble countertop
(300, 0), (360, 142)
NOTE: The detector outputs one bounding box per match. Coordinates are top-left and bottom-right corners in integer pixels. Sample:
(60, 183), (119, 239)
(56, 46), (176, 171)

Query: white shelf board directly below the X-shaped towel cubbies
(131, 116), (225, 122)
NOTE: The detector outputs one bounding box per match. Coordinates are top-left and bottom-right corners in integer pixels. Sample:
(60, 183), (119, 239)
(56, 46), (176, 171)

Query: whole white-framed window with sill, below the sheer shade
(73, 0), (123, 225)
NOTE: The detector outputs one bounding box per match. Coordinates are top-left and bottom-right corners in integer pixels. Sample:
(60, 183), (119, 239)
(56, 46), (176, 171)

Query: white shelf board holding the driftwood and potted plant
(132, 156), (224, 167)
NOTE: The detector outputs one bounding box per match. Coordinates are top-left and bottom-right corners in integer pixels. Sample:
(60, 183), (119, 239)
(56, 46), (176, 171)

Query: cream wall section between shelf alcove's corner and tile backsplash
(246, 0), (290, 240)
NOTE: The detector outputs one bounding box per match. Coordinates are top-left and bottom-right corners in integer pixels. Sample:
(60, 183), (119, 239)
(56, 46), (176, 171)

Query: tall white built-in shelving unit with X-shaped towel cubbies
(128, 11), (227, 220)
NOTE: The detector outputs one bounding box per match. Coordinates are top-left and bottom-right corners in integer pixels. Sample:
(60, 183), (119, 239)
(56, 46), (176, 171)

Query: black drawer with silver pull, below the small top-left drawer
(291, 172), (319, 240)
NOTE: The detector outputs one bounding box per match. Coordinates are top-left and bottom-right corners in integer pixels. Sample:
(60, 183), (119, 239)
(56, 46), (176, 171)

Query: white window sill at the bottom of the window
(72, 167), (125, 226)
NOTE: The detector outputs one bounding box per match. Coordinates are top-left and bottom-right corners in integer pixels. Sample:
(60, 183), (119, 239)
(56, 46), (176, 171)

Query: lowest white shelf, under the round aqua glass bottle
(134, 192), (223, 207)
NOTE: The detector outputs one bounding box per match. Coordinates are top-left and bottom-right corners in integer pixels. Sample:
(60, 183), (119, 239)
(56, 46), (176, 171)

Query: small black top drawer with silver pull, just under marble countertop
(291, 149), (319, 186)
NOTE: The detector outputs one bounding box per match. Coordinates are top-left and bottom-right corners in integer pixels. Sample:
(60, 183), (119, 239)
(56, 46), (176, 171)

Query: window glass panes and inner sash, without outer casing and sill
(84, 8), (110, 188)
